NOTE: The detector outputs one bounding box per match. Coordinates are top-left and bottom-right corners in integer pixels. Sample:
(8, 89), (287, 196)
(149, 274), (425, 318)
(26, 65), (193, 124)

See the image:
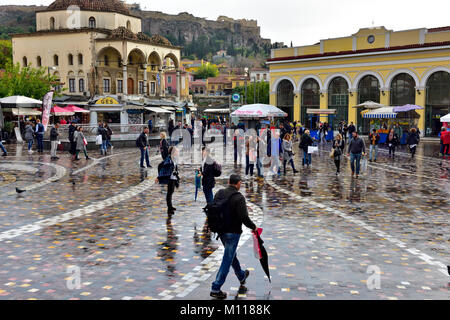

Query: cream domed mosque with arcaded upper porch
(12, 0), (189, 123)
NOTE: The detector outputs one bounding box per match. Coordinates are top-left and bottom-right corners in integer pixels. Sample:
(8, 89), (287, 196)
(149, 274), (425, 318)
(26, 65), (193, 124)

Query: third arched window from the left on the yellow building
(328, 77), (348, 129)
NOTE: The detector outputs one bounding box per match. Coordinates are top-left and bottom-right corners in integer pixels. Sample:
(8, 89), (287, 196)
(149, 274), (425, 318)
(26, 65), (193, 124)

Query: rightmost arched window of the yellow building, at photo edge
(425, 71), (450, 136)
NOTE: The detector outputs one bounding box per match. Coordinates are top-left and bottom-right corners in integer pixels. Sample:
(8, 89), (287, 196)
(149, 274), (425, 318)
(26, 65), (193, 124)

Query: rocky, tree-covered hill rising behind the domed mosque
(0, 5), (271, 58)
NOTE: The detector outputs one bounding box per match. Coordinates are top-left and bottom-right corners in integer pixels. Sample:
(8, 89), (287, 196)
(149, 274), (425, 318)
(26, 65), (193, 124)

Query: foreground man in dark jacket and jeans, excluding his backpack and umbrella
(210, 174), (257, 299)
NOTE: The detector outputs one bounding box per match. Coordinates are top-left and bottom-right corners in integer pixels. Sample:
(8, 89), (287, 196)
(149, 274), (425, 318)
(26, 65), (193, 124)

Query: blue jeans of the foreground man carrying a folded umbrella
(211, 233), (245, 293)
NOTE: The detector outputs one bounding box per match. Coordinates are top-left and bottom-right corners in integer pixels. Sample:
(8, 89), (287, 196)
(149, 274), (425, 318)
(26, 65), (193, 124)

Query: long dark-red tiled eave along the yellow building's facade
(267, 41), (450, 62)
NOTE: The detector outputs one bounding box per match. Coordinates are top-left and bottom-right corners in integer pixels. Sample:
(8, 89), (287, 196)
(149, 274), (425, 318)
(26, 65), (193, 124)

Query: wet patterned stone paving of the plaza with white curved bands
(0, 144), (450, 300)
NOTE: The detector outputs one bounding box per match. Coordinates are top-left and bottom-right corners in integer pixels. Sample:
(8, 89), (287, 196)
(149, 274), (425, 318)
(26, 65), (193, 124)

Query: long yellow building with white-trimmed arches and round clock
(267, 27), (450, 136)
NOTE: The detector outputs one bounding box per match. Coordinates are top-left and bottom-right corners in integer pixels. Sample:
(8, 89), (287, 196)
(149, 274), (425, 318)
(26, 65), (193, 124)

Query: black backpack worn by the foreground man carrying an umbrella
(204, 192), (239, 239)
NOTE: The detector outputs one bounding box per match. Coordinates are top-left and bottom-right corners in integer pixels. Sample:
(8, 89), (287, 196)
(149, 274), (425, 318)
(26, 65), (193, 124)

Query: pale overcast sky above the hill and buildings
(0, 0), (450, 46)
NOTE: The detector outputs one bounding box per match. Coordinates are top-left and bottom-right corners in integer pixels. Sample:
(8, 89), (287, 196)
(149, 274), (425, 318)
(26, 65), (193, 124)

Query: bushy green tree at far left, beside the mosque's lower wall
(0, 63), (57, 100)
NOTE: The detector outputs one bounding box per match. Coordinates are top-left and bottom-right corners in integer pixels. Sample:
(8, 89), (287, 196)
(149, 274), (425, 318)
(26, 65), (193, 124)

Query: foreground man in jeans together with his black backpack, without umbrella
(207, 174), (257, 299)
